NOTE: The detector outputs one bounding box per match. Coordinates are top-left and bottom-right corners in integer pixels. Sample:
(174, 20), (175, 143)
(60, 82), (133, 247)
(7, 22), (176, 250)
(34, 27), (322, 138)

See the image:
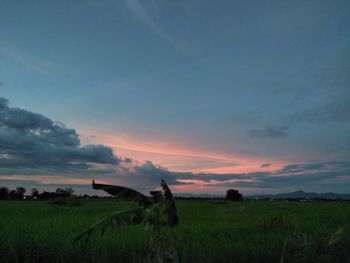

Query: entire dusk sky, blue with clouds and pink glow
(0, 0), (350, 195)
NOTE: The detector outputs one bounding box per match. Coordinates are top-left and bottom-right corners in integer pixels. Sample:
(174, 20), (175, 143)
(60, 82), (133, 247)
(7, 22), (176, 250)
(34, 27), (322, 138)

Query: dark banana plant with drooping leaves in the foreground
(74, 180), (179, 263)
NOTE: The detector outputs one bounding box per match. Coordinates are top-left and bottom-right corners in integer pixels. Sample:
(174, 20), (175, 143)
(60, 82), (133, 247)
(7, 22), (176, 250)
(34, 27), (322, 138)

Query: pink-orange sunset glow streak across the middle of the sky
(79, 128), (288, 174)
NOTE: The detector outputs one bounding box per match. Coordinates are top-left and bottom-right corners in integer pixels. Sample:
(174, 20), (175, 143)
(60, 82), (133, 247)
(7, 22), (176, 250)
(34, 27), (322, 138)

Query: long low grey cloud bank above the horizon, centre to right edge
(121, 161), (350, 191)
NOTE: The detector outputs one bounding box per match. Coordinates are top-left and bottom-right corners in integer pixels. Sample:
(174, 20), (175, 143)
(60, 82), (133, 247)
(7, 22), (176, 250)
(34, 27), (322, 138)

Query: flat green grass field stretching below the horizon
(0, 200), (350, 263)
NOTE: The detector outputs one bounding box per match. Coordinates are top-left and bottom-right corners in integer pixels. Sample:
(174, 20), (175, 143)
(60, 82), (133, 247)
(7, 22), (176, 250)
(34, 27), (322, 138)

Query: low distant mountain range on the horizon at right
(246, 191), (350, 200)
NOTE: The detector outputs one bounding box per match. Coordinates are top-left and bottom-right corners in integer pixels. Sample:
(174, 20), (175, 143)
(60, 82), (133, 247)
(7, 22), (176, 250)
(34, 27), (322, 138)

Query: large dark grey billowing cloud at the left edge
(0, 98), (121, 175)
